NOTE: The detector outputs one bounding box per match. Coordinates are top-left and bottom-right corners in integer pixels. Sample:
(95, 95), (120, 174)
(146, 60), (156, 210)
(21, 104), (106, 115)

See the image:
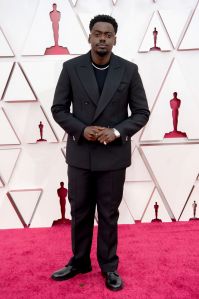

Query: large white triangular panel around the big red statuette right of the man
(141, 60), (199, 141)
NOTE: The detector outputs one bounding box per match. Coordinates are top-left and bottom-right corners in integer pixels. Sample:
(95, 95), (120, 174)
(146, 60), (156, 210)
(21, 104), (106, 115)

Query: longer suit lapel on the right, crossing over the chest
(93, 54), (124, 121)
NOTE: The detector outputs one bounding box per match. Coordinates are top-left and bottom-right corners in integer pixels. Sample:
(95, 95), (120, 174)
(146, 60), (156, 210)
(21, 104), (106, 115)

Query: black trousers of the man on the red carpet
(68, 166), (126, 272)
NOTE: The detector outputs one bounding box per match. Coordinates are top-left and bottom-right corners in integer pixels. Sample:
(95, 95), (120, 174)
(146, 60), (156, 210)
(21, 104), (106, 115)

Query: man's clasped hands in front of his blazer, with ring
(84, 126), (116, 144)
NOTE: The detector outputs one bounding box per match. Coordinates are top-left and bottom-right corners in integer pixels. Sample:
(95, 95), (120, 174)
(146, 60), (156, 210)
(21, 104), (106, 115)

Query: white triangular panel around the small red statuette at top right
(139, 12), (173, 52)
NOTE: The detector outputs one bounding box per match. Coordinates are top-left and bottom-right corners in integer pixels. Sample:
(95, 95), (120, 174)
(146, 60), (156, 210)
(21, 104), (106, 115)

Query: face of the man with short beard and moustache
(88, 22), (116, 56)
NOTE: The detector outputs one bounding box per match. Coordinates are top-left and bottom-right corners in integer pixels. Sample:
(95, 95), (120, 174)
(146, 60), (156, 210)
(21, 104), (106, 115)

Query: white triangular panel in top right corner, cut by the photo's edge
(179, 5), (199, 50)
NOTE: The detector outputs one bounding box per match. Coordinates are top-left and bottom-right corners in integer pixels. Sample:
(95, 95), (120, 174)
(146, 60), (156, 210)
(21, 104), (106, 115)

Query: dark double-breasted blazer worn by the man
(51, 52), (150, 171)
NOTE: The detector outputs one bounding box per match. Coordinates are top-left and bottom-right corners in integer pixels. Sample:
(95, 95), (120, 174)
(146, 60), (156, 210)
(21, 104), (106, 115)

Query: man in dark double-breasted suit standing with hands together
(52, 15), (149, 291)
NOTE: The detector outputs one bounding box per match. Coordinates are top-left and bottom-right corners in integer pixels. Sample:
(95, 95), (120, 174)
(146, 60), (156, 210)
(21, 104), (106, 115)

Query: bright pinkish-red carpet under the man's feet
(0, 222), (199, 299)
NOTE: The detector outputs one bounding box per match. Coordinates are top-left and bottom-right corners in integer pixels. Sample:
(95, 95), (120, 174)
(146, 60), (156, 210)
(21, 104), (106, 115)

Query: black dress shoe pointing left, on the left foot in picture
(51, 265), (92, 280)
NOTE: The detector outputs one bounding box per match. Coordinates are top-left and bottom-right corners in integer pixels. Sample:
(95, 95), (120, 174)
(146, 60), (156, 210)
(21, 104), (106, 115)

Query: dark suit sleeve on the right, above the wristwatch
(115, 66), (150, 142)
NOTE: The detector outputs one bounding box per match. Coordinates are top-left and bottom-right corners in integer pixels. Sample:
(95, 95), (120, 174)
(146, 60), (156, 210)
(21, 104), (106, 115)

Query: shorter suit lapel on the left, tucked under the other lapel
(76, 52), (99, 105)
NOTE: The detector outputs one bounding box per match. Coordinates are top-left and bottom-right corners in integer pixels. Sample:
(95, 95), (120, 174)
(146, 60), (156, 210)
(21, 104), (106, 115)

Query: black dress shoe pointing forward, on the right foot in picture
(102, 271), (123, 291)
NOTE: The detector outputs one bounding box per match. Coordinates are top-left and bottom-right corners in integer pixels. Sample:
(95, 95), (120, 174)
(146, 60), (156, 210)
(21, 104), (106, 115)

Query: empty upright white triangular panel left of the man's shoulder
(4, 63), (36, 102)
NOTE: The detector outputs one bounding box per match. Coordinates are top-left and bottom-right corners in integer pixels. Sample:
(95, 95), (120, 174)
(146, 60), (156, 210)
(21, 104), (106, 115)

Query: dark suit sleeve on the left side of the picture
(51, 63), (86, 142)
